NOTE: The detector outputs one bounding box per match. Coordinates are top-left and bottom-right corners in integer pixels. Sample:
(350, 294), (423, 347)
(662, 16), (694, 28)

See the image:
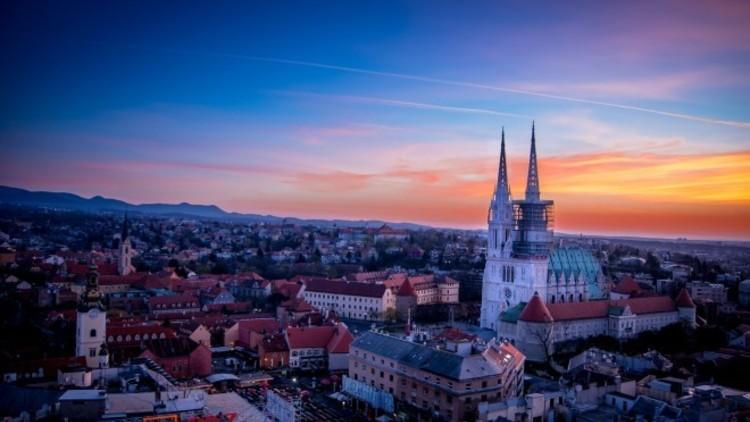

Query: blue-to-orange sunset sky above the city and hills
(0, 0), (750, 240)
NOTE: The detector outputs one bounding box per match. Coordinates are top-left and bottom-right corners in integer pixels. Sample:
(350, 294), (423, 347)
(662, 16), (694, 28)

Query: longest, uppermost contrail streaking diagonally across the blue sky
(101, 42), (750, 129)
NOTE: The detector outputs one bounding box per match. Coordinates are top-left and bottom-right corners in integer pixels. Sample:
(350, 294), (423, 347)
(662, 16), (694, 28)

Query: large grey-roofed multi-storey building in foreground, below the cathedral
(349, 331), (525, 421)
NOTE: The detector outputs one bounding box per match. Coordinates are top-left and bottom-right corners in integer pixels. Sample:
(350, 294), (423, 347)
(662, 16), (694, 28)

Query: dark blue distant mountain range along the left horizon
(0, 186), (432, 230)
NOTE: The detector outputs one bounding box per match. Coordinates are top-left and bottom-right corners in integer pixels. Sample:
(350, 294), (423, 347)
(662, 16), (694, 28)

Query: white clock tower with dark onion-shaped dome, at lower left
(76, 265), (109, 368)
